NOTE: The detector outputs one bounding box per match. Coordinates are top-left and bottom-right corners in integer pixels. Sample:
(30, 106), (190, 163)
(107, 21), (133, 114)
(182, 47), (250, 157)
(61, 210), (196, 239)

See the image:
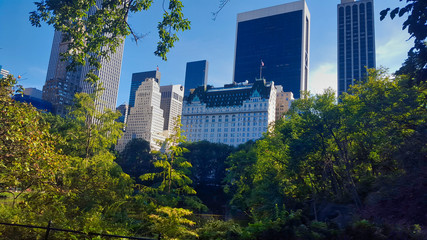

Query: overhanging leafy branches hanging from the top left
(30, 0), (190, 82)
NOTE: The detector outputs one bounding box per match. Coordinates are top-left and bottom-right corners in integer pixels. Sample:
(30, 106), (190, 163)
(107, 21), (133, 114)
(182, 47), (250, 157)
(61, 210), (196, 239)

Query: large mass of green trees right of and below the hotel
(225, 70), (427, 227)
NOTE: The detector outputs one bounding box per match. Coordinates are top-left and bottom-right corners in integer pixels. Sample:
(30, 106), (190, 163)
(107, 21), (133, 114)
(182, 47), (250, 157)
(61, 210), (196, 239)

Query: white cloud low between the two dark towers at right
(308, 62), (337, 94)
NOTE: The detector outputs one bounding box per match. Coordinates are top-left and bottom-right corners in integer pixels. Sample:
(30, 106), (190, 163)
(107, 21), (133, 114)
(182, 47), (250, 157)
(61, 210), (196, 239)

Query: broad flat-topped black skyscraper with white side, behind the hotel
(234, 1), (310, 98)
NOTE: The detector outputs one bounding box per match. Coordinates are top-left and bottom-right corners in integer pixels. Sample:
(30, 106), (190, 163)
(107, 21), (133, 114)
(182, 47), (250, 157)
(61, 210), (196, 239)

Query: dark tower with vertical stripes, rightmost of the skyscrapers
(338, 0), (376, 95)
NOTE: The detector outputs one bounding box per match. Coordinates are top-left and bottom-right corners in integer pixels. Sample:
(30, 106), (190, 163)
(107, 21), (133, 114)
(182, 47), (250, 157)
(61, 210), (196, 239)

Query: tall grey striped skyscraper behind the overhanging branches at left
(43, 0), (124, 115)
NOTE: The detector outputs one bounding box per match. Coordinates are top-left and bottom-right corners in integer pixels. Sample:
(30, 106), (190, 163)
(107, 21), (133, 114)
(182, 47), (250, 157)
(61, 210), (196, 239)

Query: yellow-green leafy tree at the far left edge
(0, 75), (63, 206)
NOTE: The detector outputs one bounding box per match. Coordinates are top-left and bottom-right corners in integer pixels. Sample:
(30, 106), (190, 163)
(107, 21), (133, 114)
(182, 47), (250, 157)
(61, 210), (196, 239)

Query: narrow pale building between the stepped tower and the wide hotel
(160, 85), (184, 134)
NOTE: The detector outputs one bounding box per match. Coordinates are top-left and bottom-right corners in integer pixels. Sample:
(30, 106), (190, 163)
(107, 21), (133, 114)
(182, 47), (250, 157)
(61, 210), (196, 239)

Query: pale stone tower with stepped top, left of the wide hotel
(116, 78), (165, 151)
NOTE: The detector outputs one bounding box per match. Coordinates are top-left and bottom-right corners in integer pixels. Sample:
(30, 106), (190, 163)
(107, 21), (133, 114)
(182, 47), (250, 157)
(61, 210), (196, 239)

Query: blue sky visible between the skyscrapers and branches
(0, 0), (412, 105)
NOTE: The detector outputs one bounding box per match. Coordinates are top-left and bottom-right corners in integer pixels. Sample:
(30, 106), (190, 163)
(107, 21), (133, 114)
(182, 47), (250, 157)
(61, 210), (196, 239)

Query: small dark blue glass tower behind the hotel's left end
(184, 60), (209, 97)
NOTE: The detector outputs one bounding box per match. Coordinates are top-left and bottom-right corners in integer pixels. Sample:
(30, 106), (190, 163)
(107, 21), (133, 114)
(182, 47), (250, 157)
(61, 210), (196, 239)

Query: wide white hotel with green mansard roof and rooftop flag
(182, 79), (276, 146)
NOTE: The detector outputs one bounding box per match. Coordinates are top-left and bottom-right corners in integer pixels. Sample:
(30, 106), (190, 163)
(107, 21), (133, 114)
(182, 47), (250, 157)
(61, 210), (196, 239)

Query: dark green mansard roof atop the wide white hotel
(186, 79), (274, 107)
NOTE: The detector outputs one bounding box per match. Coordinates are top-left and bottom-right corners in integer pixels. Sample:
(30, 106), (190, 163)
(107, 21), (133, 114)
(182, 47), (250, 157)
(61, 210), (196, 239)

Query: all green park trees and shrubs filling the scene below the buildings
(0, 1), (427, 240)
